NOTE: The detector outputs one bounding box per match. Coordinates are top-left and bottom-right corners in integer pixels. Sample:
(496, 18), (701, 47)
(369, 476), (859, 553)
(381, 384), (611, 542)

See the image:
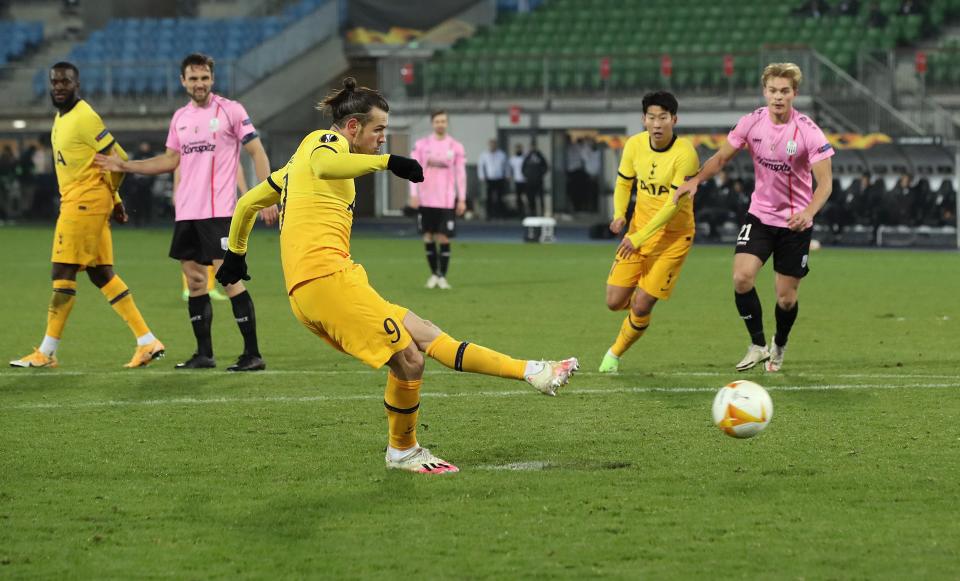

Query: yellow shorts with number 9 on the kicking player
(290, 264), (412, 369)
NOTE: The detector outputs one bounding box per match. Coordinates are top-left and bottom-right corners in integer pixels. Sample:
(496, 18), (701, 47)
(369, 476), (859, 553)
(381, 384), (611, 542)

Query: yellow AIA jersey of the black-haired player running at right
(614, 131), (700, 234)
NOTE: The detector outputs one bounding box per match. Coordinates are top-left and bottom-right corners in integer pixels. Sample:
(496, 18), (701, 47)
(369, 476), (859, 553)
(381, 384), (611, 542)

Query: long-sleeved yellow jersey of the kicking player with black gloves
(229, 130), (390, 292)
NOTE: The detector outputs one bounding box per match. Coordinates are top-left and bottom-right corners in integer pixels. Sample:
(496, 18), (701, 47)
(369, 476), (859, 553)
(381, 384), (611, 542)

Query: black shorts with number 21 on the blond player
(736, 213), (813, 278)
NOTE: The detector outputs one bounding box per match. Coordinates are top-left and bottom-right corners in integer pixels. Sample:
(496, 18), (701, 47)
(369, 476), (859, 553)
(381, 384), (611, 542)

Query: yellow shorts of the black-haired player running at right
(607, 232), (693, 299)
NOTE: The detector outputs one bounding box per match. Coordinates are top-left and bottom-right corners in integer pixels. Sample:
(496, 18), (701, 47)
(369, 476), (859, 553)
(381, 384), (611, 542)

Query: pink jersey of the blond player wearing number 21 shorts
(727, 107), (834, 228)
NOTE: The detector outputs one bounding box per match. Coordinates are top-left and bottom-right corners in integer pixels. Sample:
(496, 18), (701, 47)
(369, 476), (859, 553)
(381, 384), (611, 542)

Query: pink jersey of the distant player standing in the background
(410, 135), (467, 209)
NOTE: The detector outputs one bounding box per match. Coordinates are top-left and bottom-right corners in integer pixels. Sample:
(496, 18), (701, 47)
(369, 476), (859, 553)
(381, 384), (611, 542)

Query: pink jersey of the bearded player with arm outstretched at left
(167, 94), (258, 221)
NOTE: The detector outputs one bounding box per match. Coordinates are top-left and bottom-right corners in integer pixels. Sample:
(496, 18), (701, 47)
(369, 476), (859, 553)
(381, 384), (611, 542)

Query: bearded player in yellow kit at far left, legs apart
(10, 62), (165, 367)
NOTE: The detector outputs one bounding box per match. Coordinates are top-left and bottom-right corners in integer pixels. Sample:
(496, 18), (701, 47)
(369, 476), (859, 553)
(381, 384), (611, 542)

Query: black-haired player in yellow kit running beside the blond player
(600, 91), (700, 373)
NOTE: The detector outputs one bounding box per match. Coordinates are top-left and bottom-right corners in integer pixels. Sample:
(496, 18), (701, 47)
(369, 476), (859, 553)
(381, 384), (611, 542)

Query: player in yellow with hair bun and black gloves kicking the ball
(217, 77), (578, 474)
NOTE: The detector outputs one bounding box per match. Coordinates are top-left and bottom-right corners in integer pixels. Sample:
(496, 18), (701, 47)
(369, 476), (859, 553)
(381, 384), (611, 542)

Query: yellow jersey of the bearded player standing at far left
(50, 99), (119, 214)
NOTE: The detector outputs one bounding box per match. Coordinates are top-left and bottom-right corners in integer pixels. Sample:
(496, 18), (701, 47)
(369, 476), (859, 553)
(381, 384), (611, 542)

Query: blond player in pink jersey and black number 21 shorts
(674, 63), (834, 371)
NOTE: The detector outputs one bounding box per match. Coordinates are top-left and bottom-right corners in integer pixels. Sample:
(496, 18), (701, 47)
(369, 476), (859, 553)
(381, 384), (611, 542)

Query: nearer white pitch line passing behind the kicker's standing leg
(0, 381), (960, 411)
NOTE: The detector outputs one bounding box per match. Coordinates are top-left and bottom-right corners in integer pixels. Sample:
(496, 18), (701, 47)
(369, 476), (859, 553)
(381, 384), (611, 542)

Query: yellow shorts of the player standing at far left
(50, 214), (113, 266)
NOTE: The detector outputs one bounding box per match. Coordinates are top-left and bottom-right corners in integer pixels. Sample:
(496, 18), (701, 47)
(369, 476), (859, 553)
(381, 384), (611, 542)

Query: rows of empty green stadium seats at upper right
(423, 0), (948, 93)
